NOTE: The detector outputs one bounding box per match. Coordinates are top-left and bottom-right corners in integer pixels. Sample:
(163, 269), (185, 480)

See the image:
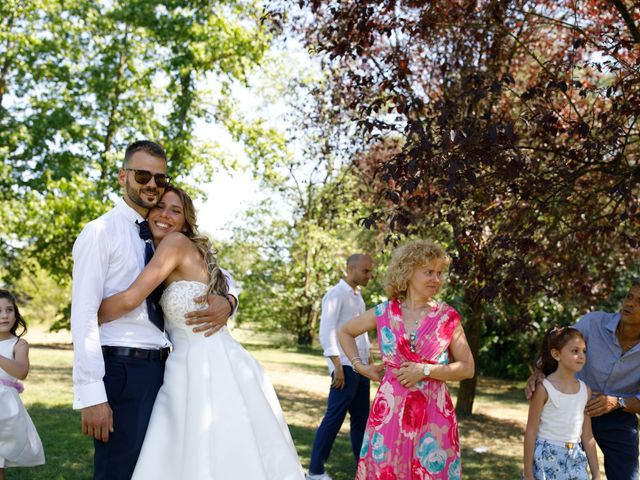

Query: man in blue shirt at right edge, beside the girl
(525, 279), (640, 480)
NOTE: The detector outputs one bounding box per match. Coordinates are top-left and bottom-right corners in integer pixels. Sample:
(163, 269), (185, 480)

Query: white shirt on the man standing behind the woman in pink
(320, 280), (370, 373)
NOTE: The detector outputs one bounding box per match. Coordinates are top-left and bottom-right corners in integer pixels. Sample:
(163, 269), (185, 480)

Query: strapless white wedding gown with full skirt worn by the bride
(133, 280), (304, 480)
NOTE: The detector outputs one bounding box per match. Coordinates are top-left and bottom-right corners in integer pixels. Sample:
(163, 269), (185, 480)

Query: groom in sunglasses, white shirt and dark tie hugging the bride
(71, 140), (237, 480)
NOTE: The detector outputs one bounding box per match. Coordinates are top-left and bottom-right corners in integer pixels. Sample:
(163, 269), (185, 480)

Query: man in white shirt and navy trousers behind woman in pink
(307, 254), (373, 480)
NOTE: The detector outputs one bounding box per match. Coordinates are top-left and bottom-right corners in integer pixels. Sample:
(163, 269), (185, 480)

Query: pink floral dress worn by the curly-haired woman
(356, 300), (461, 480)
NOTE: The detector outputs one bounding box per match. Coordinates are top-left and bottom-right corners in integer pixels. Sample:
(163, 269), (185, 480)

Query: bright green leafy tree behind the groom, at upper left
(0, 0), (271, 326)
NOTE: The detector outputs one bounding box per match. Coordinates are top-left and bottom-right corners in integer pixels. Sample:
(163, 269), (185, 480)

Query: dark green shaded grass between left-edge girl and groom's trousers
(7, 403), (93, 480)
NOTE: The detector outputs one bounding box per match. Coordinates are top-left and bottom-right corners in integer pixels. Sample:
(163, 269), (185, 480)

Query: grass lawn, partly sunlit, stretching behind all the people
(7, 330), (596, 480)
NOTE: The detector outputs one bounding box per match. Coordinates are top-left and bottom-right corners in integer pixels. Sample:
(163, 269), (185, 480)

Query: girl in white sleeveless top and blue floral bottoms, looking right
(524, 327), (600, 480)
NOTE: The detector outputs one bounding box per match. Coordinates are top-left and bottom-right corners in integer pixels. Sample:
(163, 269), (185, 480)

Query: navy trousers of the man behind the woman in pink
(309, 366), (369, 475)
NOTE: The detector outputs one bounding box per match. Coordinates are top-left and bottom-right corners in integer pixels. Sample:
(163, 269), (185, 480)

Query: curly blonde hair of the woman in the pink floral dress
(384, 240), (451, 300)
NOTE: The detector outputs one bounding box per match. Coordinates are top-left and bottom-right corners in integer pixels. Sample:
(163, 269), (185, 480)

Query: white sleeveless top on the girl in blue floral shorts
(538, 378), (588, 443)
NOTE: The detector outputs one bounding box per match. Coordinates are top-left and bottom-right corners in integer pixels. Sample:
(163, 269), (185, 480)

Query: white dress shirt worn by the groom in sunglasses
(71, 200), (238, 409)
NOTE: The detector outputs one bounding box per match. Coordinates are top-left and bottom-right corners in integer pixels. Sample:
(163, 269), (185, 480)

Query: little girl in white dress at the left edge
(0, 289), (44, 480)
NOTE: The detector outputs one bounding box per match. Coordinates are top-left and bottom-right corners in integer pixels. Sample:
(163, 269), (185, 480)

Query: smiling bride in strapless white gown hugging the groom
(99, 187), (304, 480)
